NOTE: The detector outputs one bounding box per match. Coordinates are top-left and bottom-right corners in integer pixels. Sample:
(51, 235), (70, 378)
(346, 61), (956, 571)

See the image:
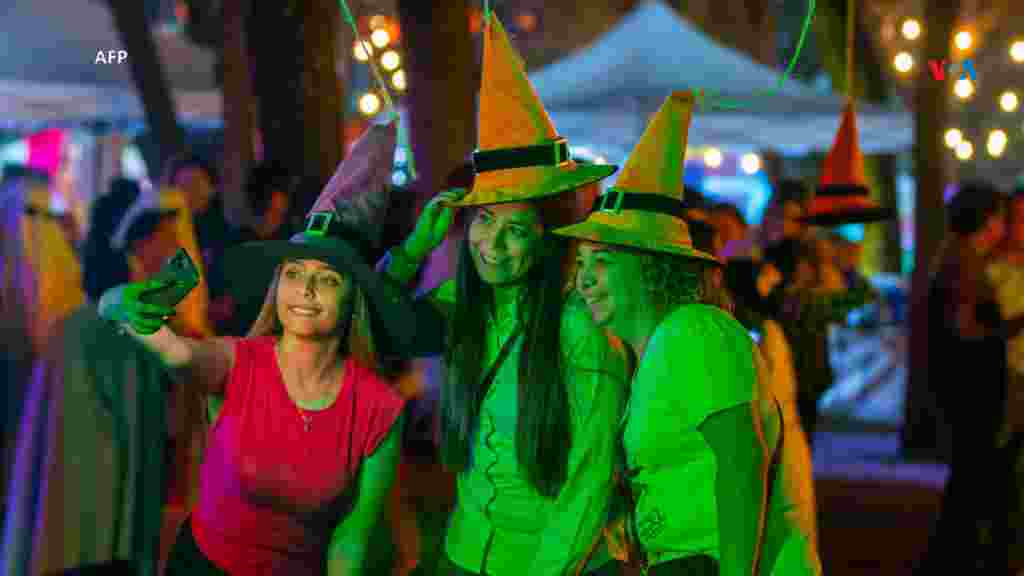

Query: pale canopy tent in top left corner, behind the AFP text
(0, 0), (221, 128)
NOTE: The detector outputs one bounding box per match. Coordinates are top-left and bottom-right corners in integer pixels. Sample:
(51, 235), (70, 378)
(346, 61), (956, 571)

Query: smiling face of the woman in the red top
(276, 256), (352, 338)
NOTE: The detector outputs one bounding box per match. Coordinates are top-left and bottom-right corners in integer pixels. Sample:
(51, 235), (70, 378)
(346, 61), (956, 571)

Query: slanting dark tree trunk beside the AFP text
(109, 0), (185, 174)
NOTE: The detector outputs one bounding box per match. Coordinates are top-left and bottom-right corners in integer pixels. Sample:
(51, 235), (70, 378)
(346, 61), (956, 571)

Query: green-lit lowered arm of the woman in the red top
(327, 416), (402, 576)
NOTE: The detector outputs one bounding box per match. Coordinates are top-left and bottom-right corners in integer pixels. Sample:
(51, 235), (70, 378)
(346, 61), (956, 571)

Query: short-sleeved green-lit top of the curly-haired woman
(623, 304), (758, 565)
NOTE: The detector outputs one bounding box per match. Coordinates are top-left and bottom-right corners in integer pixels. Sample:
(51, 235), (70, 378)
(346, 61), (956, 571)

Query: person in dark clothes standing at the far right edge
(923, 181), (1024, 574)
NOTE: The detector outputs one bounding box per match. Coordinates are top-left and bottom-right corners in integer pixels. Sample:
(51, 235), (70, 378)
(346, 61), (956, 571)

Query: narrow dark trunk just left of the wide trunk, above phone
(221, 0), (254, 225)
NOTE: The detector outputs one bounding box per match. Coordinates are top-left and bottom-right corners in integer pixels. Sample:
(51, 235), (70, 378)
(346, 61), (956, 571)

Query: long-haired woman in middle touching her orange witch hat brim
(386, 11), (626, 576)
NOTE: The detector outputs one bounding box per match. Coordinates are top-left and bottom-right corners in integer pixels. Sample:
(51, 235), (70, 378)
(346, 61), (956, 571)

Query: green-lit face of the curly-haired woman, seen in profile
(575, 242), (653, 334)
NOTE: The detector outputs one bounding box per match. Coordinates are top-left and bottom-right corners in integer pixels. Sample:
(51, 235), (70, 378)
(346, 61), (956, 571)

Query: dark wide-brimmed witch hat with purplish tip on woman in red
(224, 120), (443, 356)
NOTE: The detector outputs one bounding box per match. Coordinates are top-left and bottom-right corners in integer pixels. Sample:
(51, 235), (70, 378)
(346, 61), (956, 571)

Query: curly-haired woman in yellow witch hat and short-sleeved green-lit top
(555, 92), (778, 576)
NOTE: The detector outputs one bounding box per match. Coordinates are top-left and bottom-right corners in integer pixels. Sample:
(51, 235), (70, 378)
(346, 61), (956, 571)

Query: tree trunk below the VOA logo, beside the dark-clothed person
(903, 1), (959, 456)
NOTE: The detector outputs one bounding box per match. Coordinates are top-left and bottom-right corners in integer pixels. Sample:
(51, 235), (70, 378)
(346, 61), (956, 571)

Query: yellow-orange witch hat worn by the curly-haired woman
(554, 90), (719, 262)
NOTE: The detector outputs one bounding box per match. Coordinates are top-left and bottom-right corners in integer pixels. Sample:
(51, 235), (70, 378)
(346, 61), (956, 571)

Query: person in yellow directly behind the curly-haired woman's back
(725, 258), (821, 574)
